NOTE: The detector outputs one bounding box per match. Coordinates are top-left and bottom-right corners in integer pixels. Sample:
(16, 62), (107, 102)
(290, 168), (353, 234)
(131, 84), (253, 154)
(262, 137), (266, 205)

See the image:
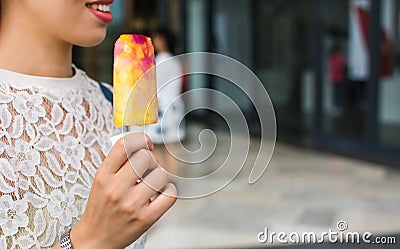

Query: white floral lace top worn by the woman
(0, 69), (145, 248)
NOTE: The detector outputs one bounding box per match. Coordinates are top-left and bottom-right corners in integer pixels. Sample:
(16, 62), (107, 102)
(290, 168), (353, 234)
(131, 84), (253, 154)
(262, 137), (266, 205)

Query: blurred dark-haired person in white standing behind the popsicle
(146, 28), (185, 174)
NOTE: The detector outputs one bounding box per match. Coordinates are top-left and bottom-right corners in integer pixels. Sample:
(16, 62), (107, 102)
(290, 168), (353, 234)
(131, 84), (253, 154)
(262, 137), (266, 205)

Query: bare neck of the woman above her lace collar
(0, 7), (73, 78)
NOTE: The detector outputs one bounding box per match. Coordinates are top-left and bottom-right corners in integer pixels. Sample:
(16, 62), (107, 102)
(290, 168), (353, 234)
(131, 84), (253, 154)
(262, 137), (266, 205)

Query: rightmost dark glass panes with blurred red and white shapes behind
(323, 0), (400, 149)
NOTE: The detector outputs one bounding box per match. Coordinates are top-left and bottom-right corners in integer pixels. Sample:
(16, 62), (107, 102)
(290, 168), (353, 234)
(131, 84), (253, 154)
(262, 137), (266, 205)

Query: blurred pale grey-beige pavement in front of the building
(146, 123), (400, 249)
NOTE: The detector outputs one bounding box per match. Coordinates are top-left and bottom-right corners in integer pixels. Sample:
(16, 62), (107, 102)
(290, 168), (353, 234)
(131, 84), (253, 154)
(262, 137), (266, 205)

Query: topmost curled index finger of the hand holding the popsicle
(103, 133), (154, 173)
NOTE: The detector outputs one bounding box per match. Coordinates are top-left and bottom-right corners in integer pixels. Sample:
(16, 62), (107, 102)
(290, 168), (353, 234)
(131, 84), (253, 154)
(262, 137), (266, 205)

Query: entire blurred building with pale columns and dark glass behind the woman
(75, 0), (400, 166)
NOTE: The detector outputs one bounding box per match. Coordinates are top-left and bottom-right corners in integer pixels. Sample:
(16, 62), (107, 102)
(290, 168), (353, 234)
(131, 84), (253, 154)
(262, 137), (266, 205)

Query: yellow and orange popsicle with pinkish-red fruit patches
(114, 34), (158, 126)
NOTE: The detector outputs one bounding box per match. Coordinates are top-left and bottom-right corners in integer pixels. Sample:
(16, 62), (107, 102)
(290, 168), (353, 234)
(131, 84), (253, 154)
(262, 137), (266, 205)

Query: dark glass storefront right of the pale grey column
(203, 0), (400, 166)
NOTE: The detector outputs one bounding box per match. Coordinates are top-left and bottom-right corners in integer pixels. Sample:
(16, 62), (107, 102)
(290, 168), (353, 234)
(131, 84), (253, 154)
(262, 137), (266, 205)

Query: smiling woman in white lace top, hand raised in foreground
(0, 0), (176, 248)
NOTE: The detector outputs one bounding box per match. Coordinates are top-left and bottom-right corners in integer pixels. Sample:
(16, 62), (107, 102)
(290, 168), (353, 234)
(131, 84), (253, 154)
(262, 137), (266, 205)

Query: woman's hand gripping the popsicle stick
(71, 133), (176, 249)
